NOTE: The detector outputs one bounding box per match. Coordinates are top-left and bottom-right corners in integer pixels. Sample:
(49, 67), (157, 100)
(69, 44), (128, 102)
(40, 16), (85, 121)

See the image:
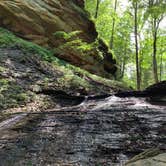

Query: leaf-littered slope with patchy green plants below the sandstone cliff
(0, 46), (124, 112)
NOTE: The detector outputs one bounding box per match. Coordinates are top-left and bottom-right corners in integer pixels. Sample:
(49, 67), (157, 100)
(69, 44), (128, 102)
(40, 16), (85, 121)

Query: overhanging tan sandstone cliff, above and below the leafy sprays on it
(0, 0), (116, 77)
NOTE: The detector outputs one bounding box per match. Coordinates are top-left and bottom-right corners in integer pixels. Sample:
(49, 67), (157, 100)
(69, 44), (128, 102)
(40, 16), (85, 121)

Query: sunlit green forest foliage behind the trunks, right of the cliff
(85, 0), (166, 88)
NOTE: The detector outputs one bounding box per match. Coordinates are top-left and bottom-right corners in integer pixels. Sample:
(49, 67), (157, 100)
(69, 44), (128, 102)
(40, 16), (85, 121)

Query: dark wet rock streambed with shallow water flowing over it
(0, 97), (166, 166)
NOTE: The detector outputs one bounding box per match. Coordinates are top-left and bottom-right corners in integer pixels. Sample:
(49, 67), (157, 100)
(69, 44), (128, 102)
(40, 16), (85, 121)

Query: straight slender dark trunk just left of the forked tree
(134, 2), (141, 90)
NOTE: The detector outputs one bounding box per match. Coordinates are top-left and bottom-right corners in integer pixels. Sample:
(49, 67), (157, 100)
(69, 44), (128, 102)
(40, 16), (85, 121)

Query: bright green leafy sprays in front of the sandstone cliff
(54, 31), (103, 61)
